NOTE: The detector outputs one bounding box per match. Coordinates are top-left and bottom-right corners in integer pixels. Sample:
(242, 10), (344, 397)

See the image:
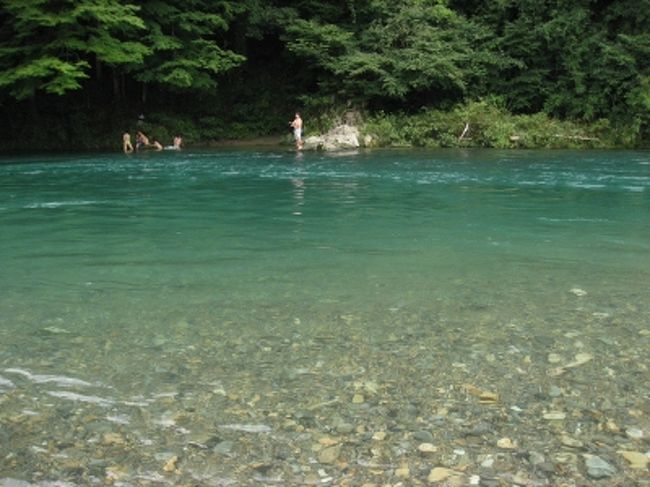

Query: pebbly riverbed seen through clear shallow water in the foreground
(0, 284), (648, 487)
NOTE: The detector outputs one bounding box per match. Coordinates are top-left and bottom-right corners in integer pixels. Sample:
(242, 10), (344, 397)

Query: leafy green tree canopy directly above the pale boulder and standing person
(286, 0), (471, 108)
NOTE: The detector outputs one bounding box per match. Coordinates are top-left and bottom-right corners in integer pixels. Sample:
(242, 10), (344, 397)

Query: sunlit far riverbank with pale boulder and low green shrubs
(186, 102), (648, 151)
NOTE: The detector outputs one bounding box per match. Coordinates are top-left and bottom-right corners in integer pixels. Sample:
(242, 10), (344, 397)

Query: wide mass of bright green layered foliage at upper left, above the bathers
(0, 0), (245, 99)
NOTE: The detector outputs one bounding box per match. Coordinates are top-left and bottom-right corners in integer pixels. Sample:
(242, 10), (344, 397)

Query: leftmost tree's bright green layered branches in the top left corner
(0, 0), (150, 99)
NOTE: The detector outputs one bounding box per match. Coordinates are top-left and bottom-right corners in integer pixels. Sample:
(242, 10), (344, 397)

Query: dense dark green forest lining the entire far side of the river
(0, 0), (650, 150)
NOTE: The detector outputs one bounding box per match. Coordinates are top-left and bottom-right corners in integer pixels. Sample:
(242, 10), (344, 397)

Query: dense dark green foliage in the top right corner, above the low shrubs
(466, 0), (650, 126)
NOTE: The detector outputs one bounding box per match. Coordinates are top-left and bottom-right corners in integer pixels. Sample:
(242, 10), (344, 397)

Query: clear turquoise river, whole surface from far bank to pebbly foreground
(0, 151), (650, 487)
